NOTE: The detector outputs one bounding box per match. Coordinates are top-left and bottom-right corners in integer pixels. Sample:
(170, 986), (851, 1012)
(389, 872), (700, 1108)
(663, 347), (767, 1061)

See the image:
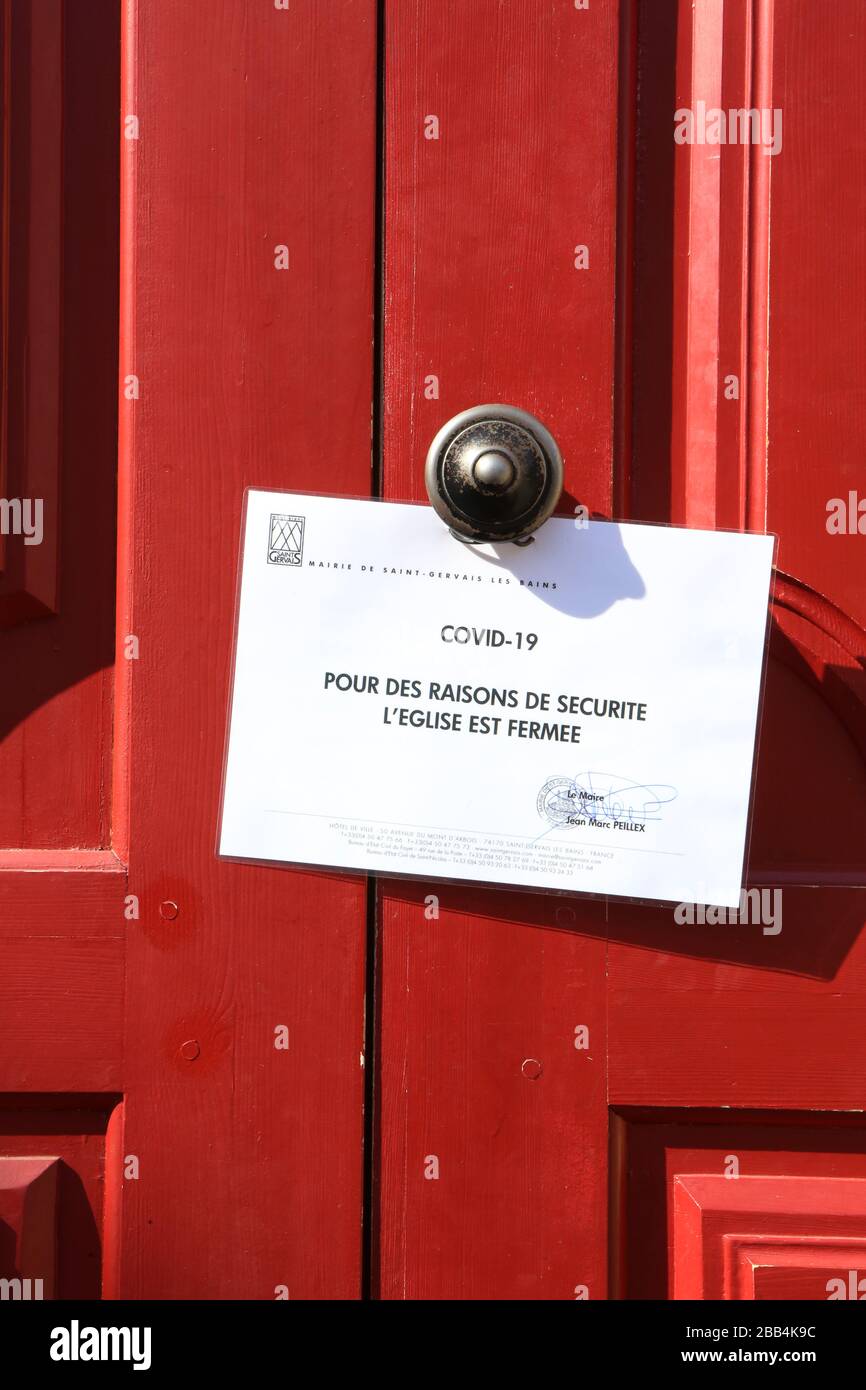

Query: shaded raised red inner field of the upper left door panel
(0, 0), (64, 628)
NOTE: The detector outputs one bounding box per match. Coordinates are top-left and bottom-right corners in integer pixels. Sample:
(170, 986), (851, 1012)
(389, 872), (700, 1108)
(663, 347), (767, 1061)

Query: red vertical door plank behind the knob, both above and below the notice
(377, 0), (619, 1300)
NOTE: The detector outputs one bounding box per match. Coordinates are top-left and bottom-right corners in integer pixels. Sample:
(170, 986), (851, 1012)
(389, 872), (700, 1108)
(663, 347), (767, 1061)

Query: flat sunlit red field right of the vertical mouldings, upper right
(767, 0), (866, 631)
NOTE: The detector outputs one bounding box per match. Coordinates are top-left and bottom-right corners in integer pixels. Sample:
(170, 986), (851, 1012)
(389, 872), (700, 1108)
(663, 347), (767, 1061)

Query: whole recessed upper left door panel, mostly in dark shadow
(0, 0), (118, 849)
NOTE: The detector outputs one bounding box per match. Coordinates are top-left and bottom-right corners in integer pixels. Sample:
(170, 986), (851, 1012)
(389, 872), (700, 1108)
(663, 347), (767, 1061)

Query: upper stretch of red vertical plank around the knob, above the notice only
(385, 0), (619, 513)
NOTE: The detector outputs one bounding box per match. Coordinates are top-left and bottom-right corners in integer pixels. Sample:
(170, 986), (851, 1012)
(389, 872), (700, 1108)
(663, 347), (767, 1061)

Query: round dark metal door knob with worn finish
(424, 406), (563, 543)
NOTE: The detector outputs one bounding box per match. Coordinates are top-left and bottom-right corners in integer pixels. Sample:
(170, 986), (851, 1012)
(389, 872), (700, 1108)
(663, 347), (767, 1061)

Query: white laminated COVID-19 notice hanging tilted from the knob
(220, 492), (773, 906)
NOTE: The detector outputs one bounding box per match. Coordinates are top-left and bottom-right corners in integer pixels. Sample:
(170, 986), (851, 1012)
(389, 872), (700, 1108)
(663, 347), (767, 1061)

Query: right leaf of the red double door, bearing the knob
(377, 0), (866, 1300)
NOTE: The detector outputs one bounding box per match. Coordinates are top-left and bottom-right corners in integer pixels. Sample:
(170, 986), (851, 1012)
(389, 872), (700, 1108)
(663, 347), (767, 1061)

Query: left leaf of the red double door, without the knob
(0, 0), (377, 1300)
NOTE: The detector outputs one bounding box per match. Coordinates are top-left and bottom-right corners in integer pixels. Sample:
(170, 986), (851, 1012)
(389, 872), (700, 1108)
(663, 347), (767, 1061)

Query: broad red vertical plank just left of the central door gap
(113, 0), (377, 1298)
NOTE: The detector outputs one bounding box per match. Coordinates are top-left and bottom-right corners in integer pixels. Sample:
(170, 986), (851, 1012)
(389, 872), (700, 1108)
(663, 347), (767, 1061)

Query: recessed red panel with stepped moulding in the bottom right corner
(612, 1106), (866, 1300)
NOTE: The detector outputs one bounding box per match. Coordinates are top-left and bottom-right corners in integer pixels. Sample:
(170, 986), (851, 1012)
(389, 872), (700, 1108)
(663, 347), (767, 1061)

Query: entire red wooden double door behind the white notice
(0, 0), (866, 1300)
